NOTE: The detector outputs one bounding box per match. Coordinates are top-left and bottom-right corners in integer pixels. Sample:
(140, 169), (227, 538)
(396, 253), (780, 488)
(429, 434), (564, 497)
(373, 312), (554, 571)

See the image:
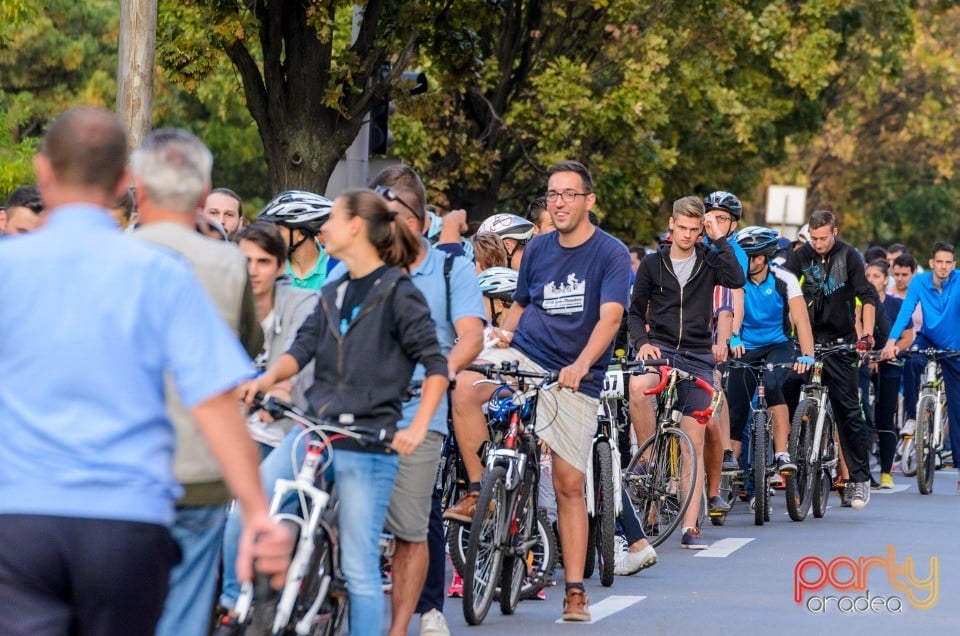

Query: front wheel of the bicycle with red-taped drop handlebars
(627, 428), (698, 547)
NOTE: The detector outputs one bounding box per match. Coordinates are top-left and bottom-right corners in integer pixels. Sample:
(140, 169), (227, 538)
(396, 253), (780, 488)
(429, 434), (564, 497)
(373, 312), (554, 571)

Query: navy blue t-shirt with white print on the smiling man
(512, 229), (630, 398)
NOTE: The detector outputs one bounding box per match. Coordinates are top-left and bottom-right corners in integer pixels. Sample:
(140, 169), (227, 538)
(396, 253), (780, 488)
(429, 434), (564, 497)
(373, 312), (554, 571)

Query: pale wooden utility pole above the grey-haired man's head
(117, 0), (157, 148)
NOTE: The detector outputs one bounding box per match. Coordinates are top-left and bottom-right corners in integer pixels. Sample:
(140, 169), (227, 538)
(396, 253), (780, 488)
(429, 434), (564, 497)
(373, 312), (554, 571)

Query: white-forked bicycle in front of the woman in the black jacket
(235, 394), (392, 636)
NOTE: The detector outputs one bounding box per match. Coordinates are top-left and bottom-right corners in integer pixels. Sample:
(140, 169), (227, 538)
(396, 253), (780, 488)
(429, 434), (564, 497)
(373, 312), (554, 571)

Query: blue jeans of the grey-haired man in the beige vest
(157, 506), (227, 636)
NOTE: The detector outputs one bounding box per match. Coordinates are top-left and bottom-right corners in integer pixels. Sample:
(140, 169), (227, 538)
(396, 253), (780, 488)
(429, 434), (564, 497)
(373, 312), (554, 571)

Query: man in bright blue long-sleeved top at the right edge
(883, 241), (960, 484)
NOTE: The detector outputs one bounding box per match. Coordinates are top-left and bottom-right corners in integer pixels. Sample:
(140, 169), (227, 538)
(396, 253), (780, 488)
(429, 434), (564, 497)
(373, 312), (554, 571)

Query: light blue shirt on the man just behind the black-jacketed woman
(328, 239), (487, 435)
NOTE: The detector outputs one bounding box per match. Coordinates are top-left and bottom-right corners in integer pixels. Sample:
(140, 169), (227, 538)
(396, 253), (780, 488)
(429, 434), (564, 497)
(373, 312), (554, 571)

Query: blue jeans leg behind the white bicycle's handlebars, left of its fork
(220, 427), (306, 609)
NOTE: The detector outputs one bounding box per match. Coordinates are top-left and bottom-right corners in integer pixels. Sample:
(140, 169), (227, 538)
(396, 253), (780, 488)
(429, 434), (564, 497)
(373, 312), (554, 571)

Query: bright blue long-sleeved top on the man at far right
(888, 271), (960, 349)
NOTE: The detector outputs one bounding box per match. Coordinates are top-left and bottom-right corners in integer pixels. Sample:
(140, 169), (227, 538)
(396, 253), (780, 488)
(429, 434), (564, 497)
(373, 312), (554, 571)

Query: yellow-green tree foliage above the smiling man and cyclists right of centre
(397, 0), (906, 240)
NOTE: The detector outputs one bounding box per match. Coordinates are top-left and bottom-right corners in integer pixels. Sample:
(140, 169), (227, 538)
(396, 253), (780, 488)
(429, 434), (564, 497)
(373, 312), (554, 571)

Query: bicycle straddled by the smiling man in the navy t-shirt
(463, 362), (558, 625)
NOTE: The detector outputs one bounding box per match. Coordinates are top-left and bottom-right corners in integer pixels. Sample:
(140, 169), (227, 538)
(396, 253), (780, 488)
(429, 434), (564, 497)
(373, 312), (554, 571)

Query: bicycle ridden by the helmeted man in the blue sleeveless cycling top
(711, 358), (802, 526)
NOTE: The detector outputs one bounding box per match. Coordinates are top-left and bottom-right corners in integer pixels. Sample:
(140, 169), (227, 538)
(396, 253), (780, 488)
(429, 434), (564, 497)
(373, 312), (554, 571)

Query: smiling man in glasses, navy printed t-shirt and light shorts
(445, 161), (630, 621)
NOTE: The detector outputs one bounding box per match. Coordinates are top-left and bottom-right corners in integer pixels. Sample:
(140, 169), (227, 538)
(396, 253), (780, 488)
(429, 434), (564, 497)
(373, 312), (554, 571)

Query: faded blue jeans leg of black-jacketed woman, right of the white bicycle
(333, 451), (400, 635)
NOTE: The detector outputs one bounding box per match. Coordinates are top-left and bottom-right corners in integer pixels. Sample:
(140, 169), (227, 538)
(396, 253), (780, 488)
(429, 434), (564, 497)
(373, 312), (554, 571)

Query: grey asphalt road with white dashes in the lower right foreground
(418, 470), (960, 636)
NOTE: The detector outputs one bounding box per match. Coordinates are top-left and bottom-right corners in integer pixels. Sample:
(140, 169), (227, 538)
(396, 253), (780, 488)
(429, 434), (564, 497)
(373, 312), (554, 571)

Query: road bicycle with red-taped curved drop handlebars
(623, 360), (722, 547)
